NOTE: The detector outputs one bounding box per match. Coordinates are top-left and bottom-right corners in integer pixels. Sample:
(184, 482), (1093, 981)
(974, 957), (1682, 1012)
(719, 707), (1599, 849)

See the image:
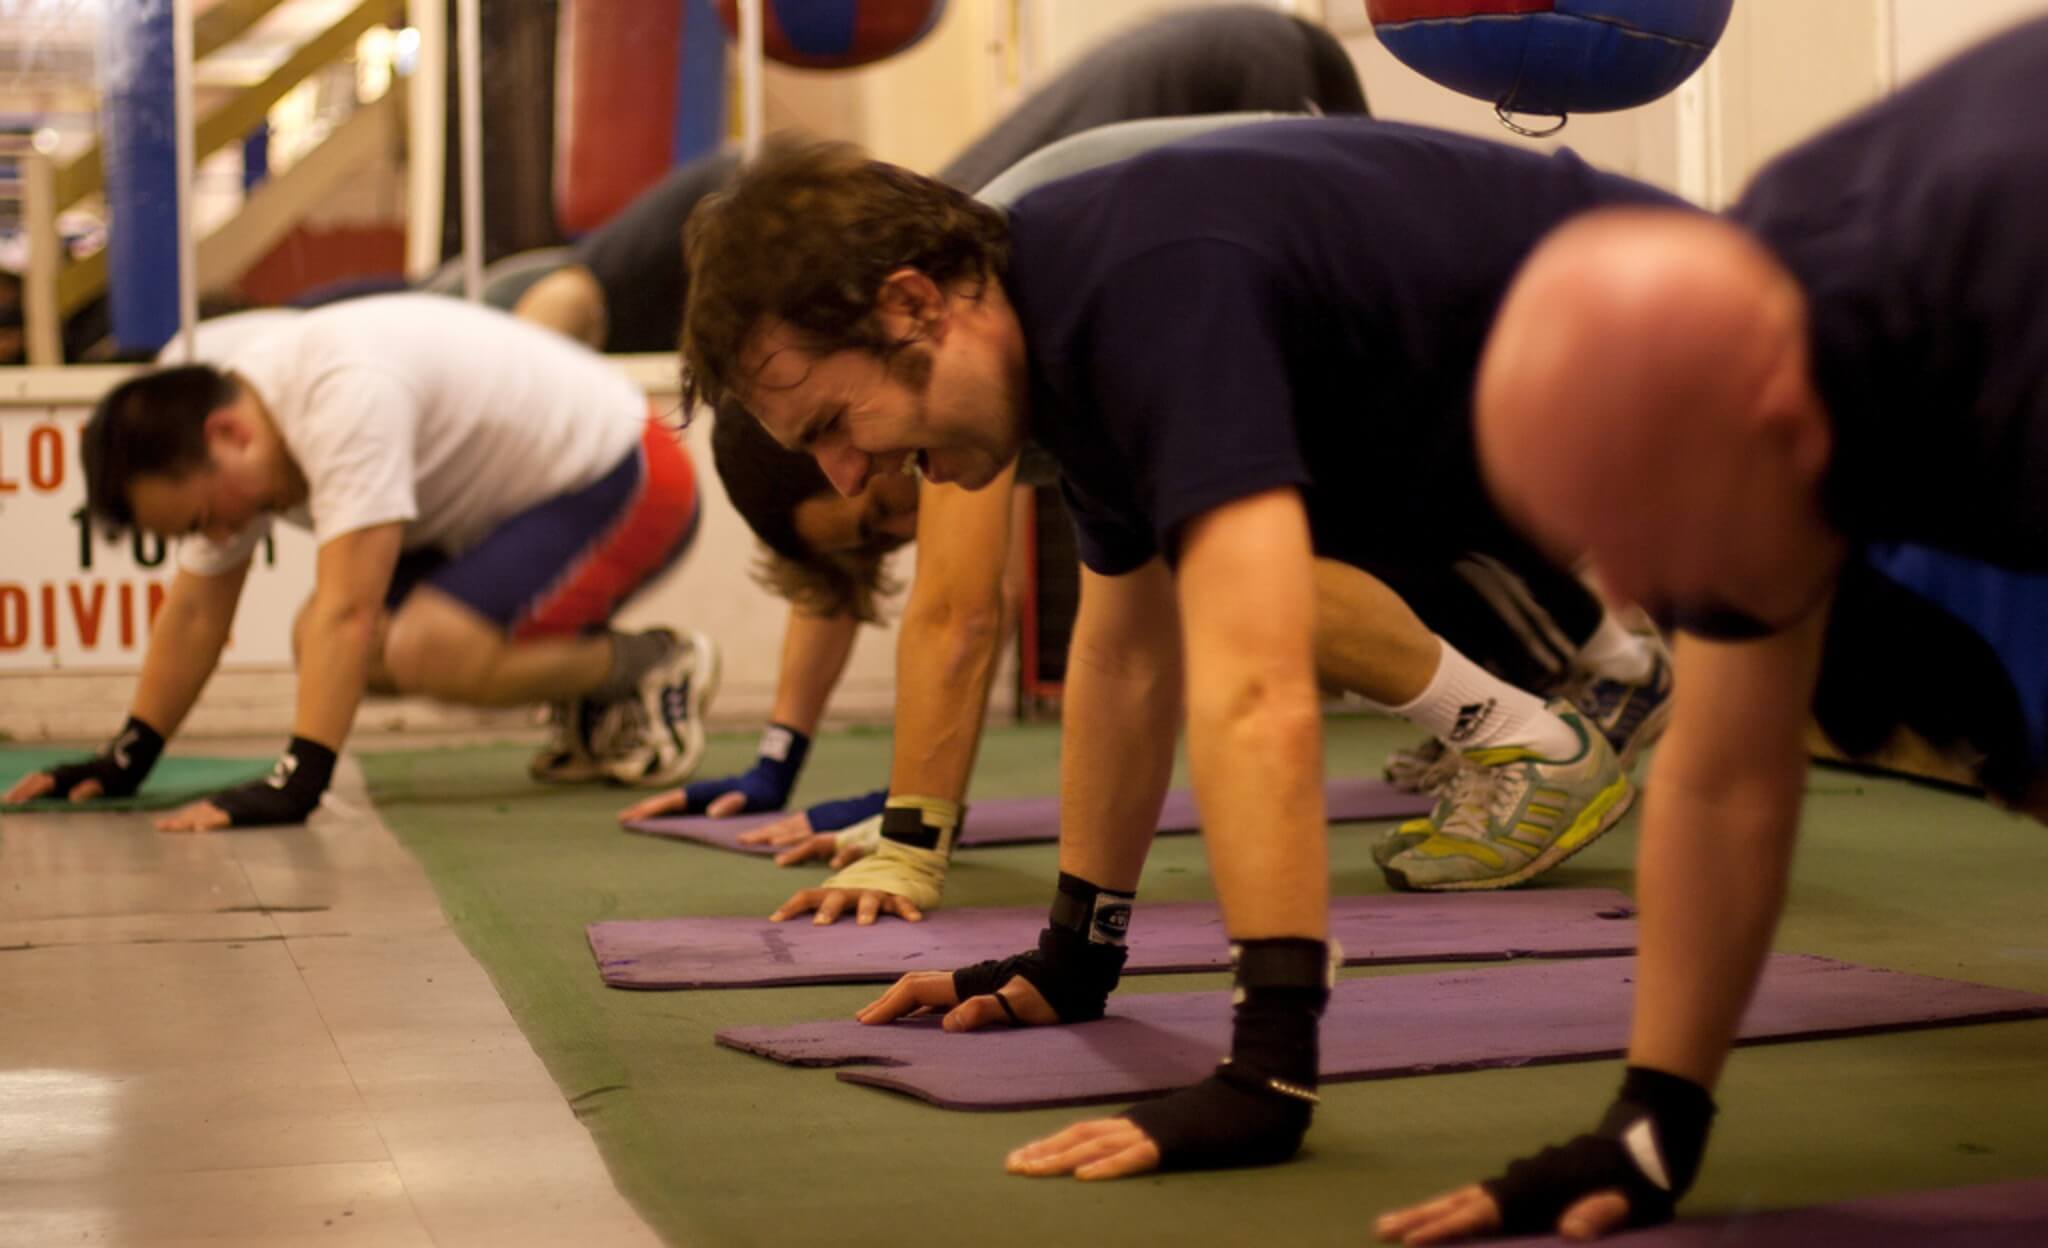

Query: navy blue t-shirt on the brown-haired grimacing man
(1006, 119), (1675, 576)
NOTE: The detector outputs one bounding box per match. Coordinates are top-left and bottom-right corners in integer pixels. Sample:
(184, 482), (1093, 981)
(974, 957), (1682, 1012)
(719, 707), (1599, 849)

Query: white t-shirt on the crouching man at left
(178, 295), (647, 576)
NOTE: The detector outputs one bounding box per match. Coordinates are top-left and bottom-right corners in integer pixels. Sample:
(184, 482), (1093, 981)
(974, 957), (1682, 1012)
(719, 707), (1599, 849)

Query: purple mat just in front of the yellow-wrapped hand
(590, 889), (1636, 988)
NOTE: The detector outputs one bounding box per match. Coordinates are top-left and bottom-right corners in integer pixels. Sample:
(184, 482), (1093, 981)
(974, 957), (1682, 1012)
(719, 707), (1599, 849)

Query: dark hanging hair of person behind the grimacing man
(711, 402), (895, 623)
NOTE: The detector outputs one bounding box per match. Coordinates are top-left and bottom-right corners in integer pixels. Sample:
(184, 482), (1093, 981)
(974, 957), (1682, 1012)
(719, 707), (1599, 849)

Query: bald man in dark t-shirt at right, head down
(1378, 23), (2048, 1244)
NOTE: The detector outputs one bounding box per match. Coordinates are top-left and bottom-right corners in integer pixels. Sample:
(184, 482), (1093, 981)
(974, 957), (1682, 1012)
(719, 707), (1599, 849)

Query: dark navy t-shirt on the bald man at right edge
(1733, 20), (2048, 570)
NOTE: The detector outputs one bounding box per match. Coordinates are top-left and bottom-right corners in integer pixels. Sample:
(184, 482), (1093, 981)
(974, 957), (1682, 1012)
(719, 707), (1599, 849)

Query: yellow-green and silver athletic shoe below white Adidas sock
(1374, 701), (1634, 891)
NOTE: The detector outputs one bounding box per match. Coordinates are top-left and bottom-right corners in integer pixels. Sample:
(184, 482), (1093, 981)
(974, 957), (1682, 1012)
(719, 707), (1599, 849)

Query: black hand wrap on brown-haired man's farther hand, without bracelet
(952, 871), (1135, 1023)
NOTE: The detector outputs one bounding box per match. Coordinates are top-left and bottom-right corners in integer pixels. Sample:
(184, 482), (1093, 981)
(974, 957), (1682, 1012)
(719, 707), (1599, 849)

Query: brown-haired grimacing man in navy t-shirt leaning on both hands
(684, 119), (1671, 1178)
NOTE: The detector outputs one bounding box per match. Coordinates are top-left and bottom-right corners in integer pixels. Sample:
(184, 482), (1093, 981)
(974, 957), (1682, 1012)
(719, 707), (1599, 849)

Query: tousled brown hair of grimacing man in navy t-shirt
(682, 135), (1010, 408)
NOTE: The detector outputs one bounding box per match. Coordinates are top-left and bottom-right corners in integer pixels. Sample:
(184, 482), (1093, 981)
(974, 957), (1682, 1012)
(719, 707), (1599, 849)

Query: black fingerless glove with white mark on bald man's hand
(1481, 1066), (1714, 1234)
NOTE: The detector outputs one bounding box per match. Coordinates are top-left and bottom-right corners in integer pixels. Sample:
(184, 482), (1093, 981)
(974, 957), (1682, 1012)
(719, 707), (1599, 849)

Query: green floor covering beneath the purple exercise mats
(365, 719), (2048, 1248)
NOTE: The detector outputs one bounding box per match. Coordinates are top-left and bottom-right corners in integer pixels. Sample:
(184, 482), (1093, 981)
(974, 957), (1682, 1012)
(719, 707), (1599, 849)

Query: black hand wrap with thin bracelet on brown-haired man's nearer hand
(1124, 937), (1337, 1170)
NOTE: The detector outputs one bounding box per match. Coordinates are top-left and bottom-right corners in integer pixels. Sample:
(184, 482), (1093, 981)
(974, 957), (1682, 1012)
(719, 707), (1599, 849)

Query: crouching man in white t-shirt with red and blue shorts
(8, 295), (717, 830)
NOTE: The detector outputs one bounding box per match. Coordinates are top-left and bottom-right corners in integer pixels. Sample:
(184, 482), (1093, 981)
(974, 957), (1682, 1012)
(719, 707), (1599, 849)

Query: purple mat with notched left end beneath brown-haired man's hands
(719, 953), (2048, 1109)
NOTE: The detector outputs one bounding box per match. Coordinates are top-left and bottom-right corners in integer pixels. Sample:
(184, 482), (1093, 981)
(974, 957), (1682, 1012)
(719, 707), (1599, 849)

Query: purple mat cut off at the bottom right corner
(1495, 1178), (2048, 1248)
